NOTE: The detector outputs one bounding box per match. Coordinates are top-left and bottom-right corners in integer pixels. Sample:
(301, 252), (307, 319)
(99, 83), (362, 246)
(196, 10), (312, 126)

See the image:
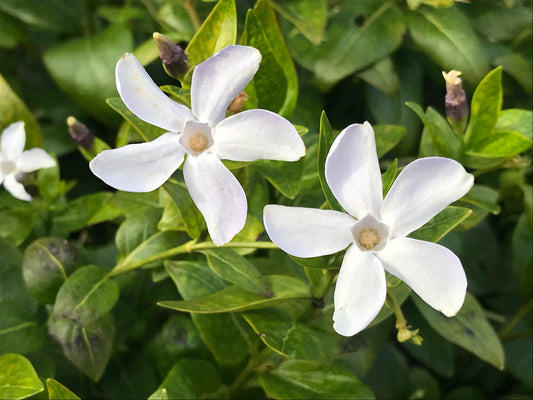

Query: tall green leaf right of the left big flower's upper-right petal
(241, 0), (298, 117)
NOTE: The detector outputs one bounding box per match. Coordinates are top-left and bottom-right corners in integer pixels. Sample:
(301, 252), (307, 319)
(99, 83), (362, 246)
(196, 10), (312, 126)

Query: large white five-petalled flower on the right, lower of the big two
(264, 122), (474, 336)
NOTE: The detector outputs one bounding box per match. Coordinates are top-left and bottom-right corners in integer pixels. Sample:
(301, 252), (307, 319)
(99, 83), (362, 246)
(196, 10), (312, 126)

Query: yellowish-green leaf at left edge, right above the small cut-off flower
(0, 74), (43, 148)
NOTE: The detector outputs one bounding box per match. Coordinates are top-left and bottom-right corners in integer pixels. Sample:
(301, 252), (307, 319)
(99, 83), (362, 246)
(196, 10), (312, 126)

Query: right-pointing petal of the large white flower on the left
(215, 110), (305, 161)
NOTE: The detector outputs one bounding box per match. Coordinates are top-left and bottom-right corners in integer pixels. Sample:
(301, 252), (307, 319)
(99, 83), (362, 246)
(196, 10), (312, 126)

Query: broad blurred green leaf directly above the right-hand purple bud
(407, 7), (488, 83)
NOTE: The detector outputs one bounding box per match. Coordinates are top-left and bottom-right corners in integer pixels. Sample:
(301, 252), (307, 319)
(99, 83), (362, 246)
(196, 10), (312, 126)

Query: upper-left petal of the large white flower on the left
(115, 53), (193, 132)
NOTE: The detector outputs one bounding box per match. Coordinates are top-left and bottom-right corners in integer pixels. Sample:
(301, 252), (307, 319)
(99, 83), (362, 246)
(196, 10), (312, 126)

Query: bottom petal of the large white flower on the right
(333, 246), (387, 336)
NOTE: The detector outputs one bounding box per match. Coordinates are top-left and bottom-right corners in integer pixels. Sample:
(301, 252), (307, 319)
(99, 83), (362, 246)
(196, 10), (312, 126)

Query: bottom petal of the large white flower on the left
(183, 153), (247, 246)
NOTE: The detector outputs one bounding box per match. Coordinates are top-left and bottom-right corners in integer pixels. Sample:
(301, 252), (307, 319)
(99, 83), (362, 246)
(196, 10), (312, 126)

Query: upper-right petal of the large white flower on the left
(191, 45), (261, 126)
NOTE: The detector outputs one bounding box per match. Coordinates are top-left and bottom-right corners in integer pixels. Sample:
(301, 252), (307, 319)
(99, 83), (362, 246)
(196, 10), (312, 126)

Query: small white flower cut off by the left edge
(0, 121), (56, 201)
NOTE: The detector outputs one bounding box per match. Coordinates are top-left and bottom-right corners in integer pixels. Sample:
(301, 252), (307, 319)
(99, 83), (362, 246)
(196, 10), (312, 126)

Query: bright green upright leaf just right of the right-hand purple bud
(465, 67), (502, 149)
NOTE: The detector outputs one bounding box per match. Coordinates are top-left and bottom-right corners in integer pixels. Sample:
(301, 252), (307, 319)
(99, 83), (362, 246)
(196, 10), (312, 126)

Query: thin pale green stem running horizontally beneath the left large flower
(109, 240), (278, 276)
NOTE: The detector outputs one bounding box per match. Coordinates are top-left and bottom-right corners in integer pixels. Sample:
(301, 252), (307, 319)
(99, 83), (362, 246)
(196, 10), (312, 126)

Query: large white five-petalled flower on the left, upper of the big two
(90, 45), (305, 246)
